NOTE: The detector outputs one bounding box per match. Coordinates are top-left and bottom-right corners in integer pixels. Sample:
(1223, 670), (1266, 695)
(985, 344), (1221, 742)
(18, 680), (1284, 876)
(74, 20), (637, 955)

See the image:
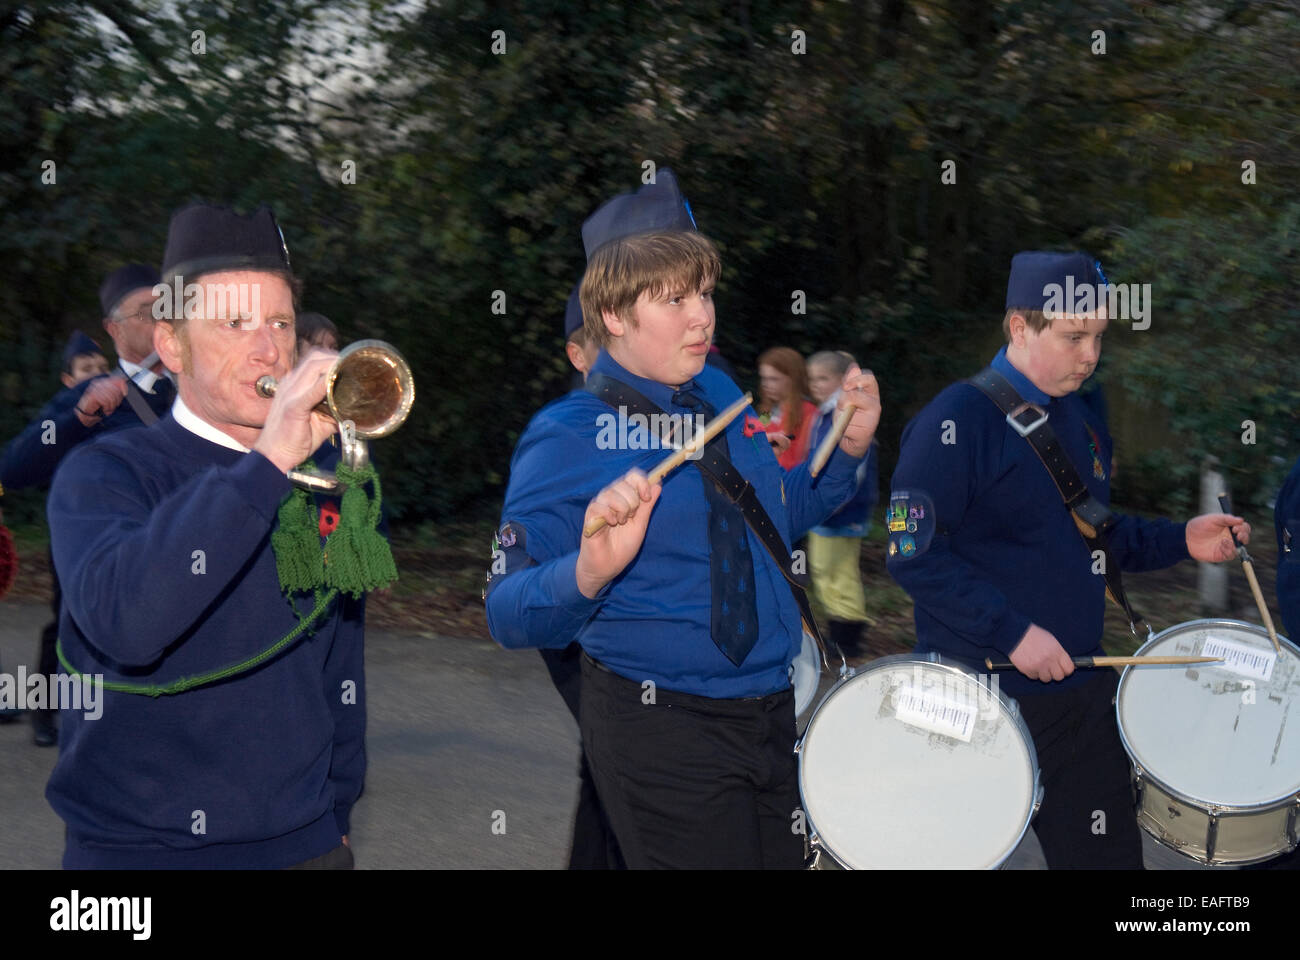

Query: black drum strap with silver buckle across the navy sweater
(969, 367), (1151, 639)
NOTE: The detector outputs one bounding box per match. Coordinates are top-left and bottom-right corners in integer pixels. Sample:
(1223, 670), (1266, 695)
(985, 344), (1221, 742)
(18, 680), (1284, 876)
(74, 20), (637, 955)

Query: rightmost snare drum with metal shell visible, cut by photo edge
(1115, 620), (1300, 864)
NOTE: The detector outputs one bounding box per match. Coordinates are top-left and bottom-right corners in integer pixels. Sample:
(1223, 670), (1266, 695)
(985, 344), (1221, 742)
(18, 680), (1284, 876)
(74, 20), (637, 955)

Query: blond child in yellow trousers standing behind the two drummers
(807, 350), (879, 660)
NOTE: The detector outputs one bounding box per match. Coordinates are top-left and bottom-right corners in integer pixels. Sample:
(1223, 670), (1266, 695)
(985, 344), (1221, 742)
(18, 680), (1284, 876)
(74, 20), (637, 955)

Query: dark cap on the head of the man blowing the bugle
(163, 203), (291, 284)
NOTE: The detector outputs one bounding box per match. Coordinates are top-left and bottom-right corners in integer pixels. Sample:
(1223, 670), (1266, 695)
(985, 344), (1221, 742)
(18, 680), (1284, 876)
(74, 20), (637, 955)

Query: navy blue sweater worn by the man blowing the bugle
(46, 416), (365, 868)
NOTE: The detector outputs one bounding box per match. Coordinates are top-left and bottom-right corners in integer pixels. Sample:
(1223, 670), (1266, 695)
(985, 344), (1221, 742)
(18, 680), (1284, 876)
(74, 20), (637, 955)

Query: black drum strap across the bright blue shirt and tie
(584, 373), (848, 673)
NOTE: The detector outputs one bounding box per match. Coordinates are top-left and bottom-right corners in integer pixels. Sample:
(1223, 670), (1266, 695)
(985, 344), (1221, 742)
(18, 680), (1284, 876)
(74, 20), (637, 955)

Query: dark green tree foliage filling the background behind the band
(0, 0), (1300, 522)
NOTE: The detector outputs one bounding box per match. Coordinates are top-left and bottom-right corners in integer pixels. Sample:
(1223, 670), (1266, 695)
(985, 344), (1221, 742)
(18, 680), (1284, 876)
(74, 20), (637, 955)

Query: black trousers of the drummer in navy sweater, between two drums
(1018, 669), (1143, 870)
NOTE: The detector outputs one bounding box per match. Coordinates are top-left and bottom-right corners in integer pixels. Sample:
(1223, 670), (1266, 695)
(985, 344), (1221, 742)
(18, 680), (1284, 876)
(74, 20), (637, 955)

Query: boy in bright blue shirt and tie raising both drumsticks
(486, 170), (880, 868)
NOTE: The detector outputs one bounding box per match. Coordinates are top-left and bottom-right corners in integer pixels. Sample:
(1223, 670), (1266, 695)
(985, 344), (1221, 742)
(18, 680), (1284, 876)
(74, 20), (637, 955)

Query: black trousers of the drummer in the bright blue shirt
(581, 654), (803, 869)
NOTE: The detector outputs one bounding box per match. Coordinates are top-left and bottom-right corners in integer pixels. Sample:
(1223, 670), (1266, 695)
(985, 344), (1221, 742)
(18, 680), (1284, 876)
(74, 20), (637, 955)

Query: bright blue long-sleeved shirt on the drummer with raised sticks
(486, 353), (861, 699)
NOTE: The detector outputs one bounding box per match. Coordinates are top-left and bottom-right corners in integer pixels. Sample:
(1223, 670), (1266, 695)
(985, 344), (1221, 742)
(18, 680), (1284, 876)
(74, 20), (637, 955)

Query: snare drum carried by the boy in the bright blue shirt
(796, 654), (1043, 870)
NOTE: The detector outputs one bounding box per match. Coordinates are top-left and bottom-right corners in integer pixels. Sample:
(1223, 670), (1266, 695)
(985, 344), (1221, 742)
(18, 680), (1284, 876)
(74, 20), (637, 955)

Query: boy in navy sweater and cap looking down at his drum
(887, 251), (1251, 869)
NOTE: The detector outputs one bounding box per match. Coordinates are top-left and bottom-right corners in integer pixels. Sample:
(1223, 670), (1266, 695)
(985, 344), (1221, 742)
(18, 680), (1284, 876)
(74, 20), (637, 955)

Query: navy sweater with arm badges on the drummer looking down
(887, 347), (1188, 696)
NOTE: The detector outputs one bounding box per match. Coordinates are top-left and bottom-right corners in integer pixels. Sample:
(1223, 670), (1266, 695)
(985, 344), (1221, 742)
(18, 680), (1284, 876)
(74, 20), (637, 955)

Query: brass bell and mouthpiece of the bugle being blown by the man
(256, 340), (415, 440)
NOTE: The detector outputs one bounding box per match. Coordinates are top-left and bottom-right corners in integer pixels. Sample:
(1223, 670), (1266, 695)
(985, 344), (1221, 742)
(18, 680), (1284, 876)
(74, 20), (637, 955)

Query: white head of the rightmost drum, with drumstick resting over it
(1115, 620), (1300, 808)
